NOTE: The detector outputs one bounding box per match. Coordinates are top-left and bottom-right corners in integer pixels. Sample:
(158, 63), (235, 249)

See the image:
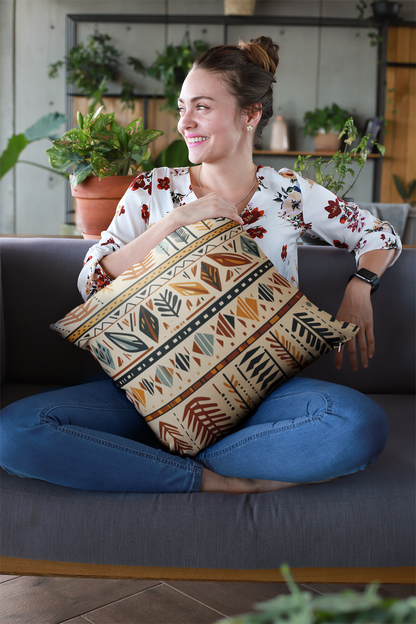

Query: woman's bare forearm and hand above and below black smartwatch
(335, 249), (395, 371)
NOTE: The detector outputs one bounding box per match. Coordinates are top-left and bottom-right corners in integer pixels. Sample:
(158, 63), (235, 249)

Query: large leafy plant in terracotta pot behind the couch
(46, 106), (163, 238)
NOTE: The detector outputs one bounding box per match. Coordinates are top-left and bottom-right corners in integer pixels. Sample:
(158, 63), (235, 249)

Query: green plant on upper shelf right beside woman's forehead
(147, 34), (209, 111)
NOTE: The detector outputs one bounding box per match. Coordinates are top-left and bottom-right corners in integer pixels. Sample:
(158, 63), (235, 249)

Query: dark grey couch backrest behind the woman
(0, 238), (416, 393)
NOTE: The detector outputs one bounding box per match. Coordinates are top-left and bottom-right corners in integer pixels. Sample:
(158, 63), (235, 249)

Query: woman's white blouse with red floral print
(78, 166), (401, 300)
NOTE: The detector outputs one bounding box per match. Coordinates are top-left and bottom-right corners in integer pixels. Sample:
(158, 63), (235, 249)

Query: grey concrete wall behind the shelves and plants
(0, 0), (416, 234)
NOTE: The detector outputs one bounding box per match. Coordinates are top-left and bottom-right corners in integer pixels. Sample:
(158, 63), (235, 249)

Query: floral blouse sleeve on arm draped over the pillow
(78, 171), (152, 301)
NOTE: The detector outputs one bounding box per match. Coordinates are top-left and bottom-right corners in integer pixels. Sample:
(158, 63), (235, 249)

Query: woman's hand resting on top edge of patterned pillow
(170, 193), (244, 229)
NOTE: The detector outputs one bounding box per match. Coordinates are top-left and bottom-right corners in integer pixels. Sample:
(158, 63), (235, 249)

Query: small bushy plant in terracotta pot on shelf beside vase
(301, 104), (350, 152)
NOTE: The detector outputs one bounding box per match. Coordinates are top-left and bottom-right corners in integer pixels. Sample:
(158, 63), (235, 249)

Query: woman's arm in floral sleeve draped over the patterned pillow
(78, 168), (242, 300)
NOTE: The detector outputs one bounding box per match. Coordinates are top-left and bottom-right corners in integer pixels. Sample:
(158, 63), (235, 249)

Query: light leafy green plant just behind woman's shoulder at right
(294, 117), (385, 198)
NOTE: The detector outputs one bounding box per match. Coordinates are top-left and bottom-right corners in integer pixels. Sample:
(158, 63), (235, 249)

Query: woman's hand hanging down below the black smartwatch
(335, 277), (375, 371)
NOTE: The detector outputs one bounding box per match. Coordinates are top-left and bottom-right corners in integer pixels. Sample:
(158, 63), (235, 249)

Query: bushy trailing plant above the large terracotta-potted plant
(48, 33), (146, 112)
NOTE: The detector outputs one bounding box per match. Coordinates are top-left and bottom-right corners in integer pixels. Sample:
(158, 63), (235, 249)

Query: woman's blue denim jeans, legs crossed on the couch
(0, 378), (388, 492)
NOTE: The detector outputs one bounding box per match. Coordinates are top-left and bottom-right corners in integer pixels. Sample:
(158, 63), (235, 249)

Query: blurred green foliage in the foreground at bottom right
(216, 566), (416, 624)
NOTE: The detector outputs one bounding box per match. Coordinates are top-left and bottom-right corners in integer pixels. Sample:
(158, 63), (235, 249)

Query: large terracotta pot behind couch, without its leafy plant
(71, 175), (137, 239)
